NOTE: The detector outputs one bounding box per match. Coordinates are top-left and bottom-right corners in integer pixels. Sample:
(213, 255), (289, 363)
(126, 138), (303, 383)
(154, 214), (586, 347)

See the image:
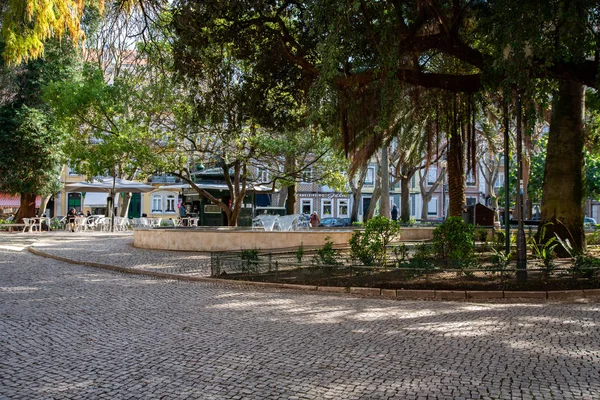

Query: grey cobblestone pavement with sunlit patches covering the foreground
(0, 234), (600, 400)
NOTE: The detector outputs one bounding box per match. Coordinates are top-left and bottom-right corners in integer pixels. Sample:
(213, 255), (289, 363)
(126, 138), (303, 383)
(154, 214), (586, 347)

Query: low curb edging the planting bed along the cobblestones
(27, 246), (600, 301)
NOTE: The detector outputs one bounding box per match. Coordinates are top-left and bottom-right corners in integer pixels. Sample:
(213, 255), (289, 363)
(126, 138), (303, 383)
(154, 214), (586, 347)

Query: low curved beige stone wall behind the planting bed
(133, 227), (433, 251)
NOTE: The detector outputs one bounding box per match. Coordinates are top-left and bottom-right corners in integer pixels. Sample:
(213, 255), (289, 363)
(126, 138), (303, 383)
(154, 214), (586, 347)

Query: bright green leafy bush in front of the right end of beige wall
(350, 215), (401, 266)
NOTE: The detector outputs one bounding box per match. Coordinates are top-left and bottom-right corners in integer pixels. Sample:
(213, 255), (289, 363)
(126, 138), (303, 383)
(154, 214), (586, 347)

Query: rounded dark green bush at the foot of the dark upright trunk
(433, 217), (475, 263)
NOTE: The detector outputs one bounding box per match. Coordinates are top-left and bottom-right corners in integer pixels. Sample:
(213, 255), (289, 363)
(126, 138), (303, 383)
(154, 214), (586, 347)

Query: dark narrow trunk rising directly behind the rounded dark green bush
(448, 129), (466, 217)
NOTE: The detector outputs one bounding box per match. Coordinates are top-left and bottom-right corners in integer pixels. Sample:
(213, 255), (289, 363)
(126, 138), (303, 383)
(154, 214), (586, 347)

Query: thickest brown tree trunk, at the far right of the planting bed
(538, 80), (585, 256)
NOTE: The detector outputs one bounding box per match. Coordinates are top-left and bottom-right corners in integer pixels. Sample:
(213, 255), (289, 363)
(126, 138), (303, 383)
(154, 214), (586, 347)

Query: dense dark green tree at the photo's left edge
(0, 40), (78, 220)
